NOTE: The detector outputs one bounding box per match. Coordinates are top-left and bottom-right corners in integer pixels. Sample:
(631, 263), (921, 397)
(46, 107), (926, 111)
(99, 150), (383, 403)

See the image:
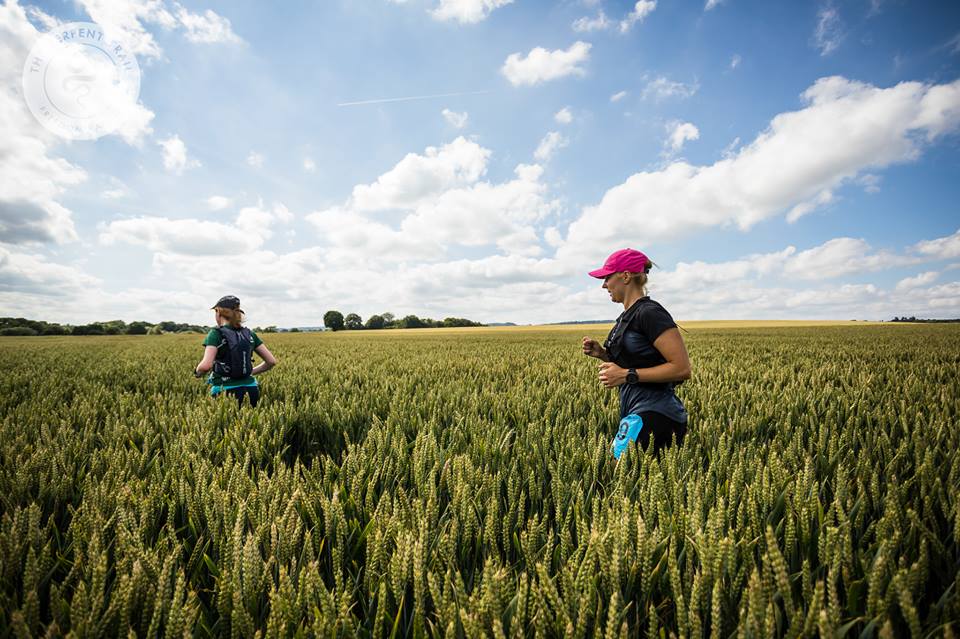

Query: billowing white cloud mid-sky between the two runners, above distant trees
(306, 138), (558, 263)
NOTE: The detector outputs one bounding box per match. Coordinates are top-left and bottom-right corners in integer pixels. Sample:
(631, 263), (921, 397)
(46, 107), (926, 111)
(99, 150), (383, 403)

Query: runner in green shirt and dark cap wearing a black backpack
(194, 295), (277, 406)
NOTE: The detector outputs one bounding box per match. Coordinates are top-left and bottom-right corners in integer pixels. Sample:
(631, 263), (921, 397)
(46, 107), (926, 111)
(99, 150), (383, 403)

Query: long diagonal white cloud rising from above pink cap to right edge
(561, 77), (960, 262)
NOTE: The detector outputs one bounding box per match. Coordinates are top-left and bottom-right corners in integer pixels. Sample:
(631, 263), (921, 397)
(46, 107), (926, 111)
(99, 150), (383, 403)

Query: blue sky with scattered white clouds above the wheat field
(0, 0), (960, 326)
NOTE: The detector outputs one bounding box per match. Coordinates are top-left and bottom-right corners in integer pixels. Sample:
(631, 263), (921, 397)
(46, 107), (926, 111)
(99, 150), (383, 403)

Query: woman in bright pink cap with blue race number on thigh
(583, 249), (690, 459)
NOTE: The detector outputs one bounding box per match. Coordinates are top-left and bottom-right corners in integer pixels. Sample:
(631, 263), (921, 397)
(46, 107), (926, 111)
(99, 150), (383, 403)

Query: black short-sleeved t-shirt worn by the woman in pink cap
(604, 297), (687, 423)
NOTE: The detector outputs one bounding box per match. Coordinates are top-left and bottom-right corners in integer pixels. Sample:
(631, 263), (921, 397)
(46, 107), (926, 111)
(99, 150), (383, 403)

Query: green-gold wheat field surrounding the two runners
(0, 325), (960, 637)
